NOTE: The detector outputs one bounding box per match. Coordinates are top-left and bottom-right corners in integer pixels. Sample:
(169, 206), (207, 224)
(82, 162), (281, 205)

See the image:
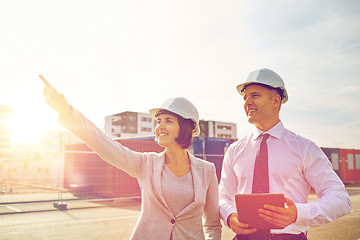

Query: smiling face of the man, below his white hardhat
(243, 84), (281, 131)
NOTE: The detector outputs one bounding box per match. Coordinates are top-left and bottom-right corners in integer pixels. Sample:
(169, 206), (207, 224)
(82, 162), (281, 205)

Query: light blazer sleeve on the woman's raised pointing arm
(58, 108), (147, 177)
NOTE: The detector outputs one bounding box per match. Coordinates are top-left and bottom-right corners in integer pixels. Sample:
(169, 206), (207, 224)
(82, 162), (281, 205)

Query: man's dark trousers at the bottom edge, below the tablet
(233, 231), (307, 240)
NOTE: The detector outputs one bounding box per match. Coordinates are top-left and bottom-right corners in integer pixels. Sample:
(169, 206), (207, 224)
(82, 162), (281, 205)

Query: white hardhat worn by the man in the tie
(236, 68), (288, 103)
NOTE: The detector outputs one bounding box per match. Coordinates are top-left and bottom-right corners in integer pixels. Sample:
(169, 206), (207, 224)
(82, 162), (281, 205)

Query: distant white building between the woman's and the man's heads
(199, 120), (237, 139)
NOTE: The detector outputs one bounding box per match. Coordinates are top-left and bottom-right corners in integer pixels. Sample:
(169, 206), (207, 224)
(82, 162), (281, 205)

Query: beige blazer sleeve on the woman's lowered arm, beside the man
(203, 164), (221, 240)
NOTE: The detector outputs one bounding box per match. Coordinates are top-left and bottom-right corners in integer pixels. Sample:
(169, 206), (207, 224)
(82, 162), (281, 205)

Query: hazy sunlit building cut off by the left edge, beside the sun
(0, 106), (14, 149)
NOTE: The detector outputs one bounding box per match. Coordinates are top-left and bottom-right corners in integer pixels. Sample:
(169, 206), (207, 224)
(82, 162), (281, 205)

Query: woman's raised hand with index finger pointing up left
(39, 75), (72, 117)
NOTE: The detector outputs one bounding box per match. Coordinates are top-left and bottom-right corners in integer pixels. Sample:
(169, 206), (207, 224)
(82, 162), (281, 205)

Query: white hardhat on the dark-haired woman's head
(149, 97), (200, 137)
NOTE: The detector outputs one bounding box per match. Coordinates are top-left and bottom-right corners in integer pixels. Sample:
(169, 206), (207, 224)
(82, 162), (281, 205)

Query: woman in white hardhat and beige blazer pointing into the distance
(40, 75), (221, 240)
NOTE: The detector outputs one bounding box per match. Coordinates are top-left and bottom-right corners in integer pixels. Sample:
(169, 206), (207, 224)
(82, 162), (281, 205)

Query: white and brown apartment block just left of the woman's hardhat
(105, 111), (156, 138)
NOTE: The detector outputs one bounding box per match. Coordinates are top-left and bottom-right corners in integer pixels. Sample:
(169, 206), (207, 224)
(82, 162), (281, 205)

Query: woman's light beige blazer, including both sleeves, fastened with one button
(59, 109), (221, 240)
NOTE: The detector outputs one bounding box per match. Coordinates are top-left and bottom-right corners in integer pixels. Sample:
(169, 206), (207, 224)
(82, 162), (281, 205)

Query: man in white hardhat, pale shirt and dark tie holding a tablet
(219, 69), (351, 239)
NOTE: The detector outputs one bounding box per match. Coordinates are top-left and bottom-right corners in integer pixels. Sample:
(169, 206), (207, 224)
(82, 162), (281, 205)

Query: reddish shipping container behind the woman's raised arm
(64, 139), (164, 198)
